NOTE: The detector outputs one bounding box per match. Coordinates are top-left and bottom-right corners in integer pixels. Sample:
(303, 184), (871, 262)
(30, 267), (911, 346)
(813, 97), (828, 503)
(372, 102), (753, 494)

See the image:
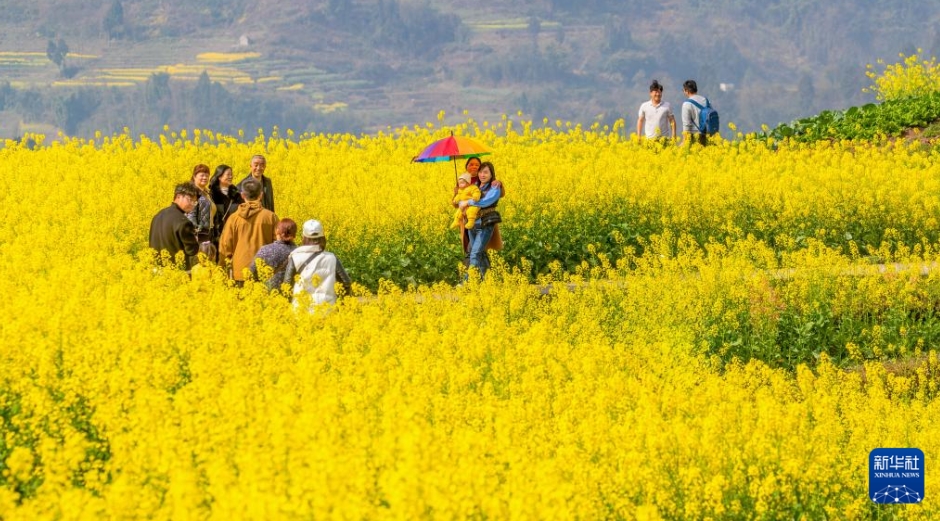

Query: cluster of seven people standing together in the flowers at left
(150, 155), (352, 305)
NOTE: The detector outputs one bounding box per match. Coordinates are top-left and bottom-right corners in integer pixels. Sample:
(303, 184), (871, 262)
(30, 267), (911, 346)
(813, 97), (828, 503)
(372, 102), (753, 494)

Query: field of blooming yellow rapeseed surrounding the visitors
(0, 117), (940, 520)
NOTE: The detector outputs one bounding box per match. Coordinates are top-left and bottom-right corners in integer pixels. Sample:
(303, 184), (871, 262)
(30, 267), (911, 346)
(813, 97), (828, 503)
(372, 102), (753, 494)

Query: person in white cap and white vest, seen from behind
(284, 219), (352, 307)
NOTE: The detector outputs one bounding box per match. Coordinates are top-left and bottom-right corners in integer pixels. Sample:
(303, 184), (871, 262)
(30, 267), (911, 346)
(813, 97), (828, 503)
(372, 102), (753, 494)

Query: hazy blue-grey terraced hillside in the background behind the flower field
(0, 0), (940, 137)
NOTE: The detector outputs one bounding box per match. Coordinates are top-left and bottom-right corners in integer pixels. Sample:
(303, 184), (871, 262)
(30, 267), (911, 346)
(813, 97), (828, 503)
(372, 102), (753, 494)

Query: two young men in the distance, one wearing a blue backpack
(636, 80), (710, 146)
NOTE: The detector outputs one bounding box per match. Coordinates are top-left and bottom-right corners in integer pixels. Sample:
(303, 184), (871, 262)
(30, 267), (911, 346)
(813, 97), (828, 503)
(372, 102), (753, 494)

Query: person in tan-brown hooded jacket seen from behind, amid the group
(219, 179), (278, 284)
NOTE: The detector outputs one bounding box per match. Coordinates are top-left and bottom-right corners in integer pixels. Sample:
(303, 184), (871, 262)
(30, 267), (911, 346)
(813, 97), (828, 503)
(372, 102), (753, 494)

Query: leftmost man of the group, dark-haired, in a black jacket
(150, 183), (199, 270)
